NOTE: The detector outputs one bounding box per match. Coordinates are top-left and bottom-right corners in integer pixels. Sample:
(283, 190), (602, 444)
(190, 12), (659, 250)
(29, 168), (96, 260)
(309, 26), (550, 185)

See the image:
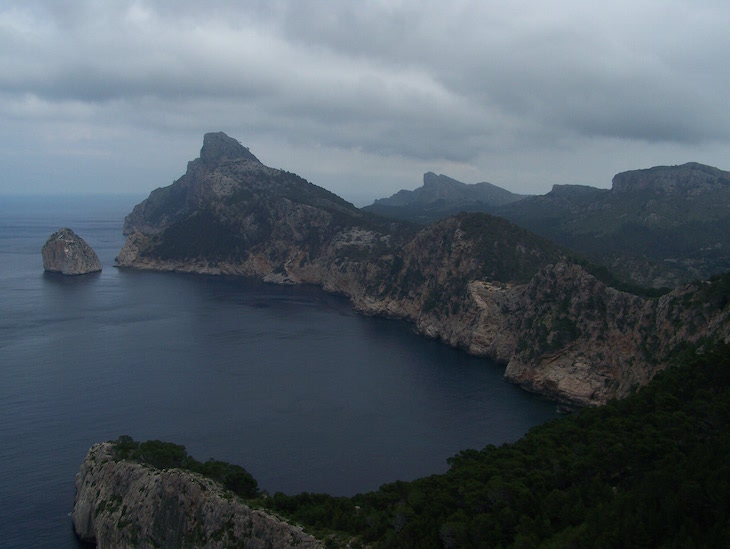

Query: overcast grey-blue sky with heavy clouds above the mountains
(0, 0), (730, 205)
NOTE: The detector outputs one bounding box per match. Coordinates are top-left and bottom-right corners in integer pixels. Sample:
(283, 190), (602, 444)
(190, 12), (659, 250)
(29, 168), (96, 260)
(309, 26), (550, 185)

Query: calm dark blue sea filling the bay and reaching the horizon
(0, 196), (555, 548)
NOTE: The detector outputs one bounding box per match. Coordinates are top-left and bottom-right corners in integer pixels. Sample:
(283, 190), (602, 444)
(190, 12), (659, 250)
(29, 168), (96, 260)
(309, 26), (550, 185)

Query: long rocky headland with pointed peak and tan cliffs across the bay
(117, 134), (728, 404)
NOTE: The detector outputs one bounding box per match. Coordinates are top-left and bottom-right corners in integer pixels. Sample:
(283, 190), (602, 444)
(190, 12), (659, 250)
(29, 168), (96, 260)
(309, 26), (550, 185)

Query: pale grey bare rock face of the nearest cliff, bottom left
(72, 443), (321, 549)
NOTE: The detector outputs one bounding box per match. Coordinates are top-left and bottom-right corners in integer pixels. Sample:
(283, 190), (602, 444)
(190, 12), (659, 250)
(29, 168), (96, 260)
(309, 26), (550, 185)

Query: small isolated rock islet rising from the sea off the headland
(41, 227), (101, 275)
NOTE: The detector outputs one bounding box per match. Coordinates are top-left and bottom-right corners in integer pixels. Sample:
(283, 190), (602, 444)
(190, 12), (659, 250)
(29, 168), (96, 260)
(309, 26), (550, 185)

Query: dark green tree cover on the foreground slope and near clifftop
(110, 340), (730, 548)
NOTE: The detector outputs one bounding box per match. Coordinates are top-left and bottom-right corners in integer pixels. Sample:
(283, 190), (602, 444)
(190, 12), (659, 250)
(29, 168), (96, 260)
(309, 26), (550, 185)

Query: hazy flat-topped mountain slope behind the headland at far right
(498, 163), (730, 287)
